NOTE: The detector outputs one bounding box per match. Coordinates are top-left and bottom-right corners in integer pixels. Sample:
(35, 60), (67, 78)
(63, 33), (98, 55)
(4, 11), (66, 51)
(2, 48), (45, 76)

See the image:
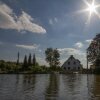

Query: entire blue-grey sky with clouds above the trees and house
(0, 0), (100, 67)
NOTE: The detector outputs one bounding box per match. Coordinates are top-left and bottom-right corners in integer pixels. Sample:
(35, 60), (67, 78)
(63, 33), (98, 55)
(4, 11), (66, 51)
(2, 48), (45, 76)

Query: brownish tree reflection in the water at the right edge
(91, 75), (100, 100)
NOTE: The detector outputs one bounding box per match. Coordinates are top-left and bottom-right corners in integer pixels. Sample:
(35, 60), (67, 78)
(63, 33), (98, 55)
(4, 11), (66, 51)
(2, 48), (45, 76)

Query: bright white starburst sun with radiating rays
(74, 0), (100, 26)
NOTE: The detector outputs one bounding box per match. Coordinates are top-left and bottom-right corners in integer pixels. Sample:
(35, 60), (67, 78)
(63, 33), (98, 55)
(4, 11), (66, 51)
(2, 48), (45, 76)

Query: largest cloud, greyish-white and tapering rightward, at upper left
(0, 3), (46, 34)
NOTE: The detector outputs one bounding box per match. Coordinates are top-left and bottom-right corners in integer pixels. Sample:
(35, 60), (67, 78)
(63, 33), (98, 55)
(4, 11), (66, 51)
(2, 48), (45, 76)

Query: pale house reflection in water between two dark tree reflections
(60, 74), (88, 100)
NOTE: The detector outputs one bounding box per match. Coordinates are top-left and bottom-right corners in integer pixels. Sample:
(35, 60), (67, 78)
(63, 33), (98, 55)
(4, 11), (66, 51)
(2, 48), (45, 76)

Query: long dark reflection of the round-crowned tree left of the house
(45, 74), (59, 100)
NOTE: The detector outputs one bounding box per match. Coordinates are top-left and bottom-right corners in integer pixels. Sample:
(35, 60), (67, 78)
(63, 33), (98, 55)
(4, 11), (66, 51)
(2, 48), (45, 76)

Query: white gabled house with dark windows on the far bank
(62, 55), (82, 71)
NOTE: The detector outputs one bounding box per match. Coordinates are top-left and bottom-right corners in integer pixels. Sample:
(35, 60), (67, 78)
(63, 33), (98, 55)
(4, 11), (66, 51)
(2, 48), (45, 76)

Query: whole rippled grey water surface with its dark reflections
(0, 74), (100, 100)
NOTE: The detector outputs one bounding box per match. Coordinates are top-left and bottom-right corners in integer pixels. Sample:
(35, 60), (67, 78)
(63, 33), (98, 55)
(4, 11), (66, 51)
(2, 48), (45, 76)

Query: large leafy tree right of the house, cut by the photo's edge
(87, 34), (100, 66)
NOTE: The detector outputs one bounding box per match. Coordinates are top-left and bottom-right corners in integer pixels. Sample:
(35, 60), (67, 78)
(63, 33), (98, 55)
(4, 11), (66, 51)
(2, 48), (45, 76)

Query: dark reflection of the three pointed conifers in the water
(23, 74), (36, 91)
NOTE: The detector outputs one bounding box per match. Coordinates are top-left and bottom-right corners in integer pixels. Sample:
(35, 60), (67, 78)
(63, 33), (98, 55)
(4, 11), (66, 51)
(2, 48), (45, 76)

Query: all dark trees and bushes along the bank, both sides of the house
(0, 31), (100, 74)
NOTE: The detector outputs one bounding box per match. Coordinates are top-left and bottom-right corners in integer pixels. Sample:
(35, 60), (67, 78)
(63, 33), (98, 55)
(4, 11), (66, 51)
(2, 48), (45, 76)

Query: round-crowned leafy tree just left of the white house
(45, 48), (60, 67)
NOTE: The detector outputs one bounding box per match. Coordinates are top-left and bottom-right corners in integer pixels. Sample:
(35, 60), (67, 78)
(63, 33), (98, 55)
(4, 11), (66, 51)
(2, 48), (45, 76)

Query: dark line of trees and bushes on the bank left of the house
(0, 48), (60, 73)
